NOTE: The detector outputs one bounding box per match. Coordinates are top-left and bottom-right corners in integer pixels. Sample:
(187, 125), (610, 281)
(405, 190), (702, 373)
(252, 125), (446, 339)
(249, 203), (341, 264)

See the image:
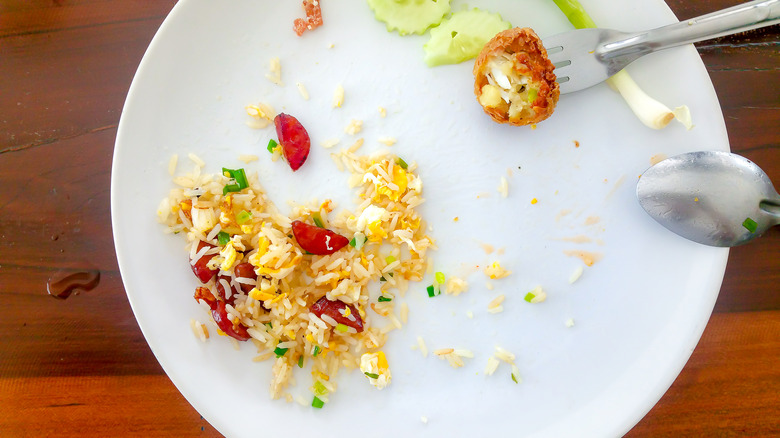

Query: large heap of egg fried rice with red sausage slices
(158, 150), (434, 407)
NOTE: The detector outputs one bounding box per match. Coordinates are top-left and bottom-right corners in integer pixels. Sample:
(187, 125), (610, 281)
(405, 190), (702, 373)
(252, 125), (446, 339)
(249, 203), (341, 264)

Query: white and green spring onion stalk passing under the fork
(553, 0), (693, 129)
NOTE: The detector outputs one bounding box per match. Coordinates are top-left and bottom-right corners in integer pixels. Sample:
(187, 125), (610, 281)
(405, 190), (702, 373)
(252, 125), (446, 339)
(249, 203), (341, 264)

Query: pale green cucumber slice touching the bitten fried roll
(423, 8), (512, 67)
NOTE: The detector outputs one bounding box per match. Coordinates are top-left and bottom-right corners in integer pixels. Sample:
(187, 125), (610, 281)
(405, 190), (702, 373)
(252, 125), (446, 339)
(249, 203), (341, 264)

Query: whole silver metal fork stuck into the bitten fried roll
(542, 0), (780, 94)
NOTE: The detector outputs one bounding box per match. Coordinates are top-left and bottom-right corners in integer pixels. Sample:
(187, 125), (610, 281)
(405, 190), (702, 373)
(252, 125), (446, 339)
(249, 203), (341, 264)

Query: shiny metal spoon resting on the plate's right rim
(636, 151), (780, 247)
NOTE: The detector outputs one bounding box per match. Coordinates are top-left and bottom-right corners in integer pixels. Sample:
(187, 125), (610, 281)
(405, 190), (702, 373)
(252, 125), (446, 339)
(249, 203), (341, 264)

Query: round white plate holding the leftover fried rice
(111, 0), (728, 437)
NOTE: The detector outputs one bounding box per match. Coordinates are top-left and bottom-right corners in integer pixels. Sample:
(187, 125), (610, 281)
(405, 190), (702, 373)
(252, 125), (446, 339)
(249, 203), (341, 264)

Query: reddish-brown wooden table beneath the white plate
(0, 0), (780, 437)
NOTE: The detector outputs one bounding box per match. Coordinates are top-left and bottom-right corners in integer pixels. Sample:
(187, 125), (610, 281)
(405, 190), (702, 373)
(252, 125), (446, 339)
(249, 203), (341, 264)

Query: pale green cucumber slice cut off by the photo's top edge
(368, 0), (450, 35)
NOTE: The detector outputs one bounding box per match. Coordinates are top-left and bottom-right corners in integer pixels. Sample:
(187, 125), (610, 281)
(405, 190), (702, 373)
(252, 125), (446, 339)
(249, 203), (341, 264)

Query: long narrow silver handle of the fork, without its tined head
(598, 0), (780, 60)
